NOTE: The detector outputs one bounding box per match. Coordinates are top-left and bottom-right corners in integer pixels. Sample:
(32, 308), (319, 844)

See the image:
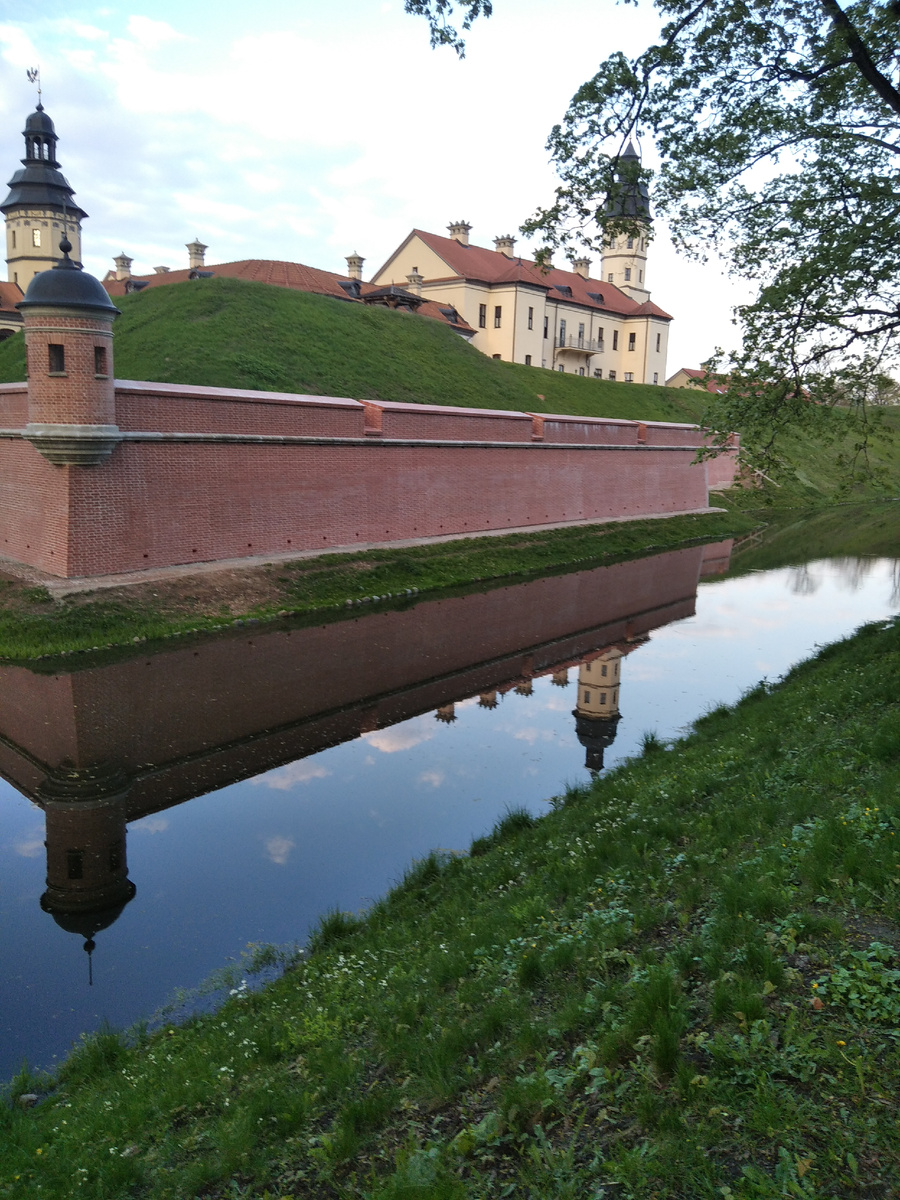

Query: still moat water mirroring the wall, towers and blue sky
(0, 520), (900, 1078)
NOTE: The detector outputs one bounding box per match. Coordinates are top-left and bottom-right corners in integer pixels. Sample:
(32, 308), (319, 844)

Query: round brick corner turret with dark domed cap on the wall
(17, 238), (120, 467)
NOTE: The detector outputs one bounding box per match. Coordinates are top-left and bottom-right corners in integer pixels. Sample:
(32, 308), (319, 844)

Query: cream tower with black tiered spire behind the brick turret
(0, 102), (88, 292)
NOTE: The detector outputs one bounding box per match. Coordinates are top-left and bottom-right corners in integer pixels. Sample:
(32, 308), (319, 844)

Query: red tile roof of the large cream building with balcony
(400, 229), (672, 320)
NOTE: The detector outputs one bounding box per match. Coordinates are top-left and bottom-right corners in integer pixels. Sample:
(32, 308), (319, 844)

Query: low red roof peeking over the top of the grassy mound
(103, 258), (474, 332)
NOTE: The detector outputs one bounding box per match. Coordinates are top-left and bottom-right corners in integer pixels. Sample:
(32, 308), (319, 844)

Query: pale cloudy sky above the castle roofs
(0, 0), (749, 374)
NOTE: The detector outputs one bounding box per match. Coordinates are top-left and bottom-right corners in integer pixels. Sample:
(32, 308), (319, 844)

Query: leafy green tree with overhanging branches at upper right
(407, 0), (900, 458)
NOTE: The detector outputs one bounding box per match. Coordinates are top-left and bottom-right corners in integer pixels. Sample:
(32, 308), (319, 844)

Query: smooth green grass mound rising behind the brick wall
(0, 278), (702, 421)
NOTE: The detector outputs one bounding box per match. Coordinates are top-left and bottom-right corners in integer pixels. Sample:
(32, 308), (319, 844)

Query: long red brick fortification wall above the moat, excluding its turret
(0, 382), (725, 577)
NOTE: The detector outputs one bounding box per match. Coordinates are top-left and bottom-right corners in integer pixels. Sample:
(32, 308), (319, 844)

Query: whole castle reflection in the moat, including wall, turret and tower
(0, 544), (730, 952)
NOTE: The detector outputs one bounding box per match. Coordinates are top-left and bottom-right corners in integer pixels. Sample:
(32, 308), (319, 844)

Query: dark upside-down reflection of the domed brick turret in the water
(38, 767), (137, 979)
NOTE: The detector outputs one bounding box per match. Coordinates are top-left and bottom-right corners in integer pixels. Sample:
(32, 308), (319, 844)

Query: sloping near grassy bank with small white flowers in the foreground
(0, 604), (900, 1200)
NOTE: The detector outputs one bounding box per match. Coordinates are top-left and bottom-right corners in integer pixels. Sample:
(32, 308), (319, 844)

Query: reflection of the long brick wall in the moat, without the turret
(0, 547), (703, 818)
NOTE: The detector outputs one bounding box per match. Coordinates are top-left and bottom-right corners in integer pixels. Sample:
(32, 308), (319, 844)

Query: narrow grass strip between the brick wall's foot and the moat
(0, 514), (752, 660)
